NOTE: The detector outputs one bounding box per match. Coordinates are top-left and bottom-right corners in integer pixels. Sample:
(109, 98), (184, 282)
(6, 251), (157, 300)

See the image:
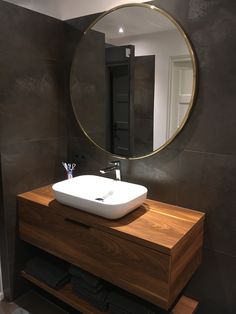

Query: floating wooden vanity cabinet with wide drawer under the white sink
(18, 186), (204, 313)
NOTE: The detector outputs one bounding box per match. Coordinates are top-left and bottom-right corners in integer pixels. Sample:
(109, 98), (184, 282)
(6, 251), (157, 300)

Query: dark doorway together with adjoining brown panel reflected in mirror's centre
(105, 45), (155, 156)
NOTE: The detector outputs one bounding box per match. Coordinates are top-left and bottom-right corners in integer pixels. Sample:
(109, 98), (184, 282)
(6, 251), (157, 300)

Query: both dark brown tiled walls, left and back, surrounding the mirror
(0, 0), (233, 314)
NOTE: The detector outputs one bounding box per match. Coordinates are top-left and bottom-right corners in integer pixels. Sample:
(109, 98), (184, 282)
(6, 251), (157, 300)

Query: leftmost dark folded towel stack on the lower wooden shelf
(25, 257), (70, 289)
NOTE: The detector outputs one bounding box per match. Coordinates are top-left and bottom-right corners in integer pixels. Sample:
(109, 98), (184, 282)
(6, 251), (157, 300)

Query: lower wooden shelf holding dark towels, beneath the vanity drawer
(21, 271), (198, 314)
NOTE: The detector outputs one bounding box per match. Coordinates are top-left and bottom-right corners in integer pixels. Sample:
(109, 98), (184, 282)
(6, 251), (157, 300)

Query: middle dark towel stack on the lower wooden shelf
(69, 266), (108, 311)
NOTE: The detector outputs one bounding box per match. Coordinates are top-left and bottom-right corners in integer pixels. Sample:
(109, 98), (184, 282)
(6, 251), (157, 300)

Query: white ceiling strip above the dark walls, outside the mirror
(4, 0), (151, 20)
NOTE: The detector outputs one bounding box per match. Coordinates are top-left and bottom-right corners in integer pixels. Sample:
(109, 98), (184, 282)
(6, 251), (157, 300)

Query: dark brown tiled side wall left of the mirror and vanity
(0, 1), (67, 299)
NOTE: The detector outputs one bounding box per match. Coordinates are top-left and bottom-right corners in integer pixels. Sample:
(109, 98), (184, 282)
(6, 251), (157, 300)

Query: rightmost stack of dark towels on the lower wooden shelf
(108, 291), (158, 314)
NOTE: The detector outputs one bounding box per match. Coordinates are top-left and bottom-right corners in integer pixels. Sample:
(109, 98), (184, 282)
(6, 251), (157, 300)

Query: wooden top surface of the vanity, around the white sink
(18, 186), (205, 255)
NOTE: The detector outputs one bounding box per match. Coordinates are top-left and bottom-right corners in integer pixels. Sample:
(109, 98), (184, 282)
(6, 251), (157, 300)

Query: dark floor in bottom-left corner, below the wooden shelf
(0, 291), (69, 314)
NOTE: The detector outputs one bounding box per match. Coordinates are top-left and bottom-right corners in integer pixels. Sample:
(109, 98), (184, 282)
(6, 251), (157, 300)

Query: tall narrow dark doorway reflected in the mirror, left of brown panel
(105, 45), (134, 156)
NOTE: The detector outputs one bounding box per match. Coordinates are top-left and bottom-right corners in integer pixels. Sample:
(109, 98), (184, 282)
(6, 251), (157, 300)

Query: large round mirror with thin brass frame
(70, 4), (196, 159)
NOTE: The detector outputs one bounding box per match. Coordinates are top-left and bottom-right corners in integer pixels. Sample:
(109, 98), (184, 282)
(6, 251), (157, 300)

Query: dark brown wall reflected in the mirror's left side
(70, 31), (107, 147)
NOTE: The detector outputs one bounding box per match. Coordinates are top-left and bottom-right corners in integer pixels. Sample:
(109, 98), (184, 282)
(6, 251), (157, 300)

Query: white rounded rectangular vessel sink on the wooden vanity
(52, 175), (147, 219)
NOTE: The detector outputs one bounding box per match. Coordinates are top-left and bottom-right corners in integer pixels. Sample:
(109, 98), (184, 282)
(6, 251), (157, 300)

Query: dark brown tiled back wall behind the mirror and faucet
(66, 0), (236, 314)
